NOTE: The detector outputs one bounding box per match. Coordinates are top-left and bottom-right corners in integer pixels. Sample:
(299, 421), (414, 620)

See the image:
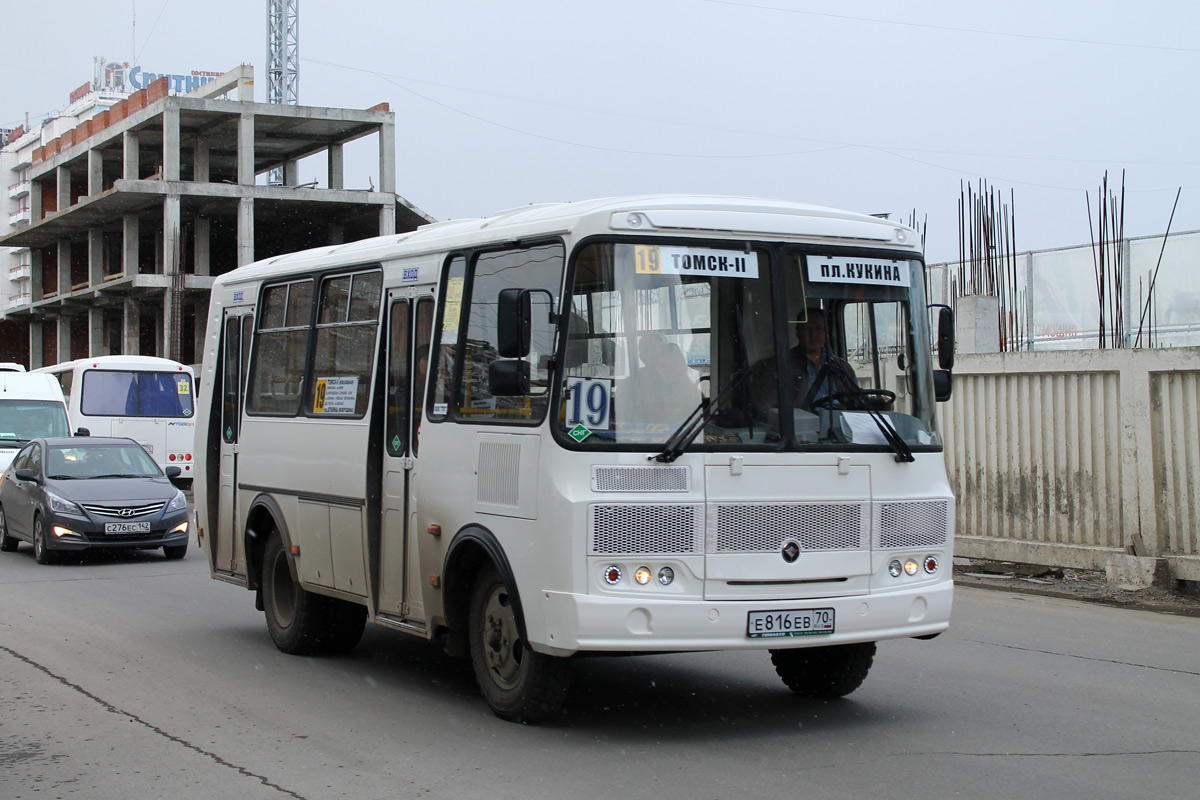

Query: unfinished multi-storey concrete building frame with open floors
(0, 67), (428, 368)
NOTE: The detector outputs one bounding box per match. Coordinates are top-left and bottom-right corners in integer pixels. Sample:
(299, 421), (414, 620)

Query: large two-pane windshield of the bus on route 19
(558, 241), (941, 451)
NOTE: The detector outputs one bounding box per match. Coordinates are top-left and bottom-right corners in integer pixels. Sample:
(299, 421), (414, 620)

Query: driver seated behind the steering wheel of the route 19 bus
(754, 308), (858, 410)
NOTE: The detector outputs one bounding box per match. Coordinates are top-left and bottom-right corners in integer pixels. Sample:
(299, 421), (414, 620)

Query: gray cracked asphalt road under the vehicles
(0, 546), (1200, 800)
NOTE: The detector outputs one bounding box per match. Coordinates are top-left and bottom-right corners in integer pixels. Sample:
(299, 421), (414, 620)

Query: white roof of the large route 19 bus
(218, 194), (920, 284)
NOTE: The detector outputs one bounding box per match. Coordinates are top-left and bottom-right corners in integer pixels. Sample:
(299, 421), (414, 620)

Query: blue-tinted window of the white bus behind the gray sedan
(79, 369), (192, 417)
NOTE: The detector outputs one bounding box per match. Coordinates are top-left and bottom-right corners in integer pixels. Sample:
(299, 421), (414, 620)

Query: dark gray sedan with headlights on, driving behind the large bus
(0, 437), (188, 564)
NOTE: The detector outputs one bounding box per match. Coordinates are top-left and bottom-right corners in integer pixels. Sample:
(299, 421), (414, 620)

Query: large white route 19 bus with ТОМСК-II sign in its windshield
(194, 196), (954, 721)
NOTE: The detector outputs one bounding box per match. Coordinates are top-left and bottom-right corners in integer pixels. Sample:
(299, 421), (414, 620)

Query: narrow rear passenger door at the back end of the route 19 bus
(212, 307), (254, 575)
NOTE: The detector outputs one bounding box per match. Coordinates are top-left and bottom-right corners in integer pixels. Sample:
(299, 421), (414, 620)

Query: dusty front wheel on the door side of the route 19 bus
(467, 565), (570, 722)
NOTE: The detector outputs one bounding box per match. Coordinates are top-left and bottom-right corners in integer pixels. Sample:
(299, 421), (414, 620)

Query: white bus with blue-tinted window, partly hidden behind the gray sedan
(36, 355), (196, 487)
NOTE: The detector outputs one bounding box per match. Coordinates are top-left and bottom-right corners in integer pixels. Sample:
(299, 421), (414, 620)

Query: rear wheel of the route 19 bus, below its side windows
(263, 531), (366, 656)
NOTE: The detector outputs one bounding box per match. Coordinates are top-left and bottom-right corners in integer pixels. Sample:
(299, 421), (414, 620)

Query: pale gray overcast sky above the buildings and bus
(0, 0), (1200, 260)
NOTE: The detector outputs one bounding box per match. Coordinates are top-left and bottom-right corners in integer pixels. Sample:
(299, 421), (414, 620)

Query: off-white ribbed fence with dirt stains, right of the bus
(942, 348), (1200, 581)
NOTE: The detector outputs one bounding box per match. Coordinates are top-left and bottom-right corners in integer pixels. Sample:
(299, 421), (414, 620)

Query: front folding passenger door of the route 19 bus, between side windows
(377, 293), (433, 622)
